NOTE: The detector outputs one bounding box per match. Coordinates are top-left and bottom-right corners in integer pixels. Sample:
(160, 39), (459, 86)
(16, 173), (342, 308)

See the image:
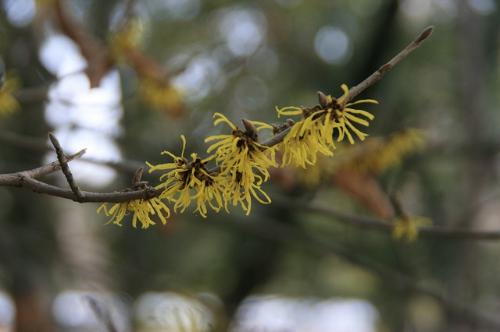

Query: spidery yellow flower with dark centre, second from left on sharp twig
(147, 135), (224, 217)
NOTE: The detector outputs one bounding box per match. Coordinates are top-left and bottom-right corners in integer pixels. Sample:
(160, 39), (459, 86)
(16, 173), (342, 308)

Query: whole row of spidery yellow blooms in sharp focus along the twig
(97, 85), (377, 228)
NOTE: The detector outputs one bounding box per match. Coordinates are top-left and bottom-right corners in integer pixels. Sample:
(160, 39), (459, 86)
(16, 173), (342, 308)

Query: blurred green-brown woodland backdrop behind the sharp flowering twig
(0, 0), (500, 332)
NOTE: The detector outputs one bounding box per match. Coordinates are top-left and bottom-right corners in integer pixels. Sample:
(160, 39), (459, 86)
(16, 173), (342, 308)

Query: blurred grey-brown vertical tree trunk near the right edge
(457, 0), (494, 226)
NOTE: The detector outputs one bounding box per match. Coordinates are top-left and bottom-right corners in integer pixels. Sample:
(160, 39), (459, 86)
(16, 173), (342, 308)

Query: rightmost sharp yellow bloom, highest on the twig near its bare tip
(276, 84), (378, 168)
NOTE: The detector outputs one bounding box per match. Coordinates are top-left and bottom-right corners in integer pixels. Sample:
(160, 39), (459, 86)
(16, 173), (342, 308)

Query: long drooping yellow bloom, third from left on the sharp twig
(205, 113), (276, 215)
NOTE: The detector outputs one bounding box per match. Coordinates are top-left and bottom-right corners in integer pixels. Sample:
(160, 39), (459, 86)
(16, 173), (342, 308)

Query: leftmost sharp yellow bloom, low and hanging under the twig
(97, 197), (170, 229)
